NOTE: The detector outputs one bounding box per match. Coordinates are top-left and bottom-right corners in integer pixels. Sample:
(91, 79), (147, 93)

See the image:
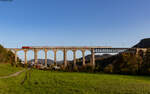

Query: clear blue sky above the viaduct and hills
(0, 0), (150, 59)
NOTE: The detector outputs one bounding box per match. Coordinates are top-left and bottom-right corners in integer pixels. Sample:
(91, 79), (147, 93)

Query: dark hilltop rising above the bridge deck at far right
(133, 38), (150, 48)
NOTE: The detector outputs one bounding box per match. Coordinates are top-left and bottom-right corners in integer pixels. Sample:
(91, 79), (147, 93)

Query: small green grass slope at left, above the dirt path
(0, 63), (22, 76)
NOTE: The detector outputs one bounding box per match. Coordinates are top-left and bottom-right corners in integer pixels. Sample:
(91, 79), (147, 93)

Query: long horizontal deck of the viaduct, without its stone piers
(5, 46), (139, 53)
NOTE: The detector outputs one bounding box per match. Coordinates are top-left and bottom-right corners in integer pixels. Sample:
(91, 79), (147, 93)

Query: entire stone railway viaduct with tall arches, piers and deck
(7, 46), (147, 67)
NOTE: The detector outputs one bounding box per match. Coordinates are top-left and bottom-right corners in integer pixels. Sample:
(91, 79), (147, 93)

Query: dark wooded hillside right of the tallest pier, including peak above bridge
(96, 38), (150, 75)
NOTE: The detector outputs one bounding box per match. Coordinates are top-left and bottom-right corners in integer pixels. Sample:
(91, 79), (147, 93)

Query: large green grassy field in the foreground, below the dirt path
(0, 63), (150, 94)
